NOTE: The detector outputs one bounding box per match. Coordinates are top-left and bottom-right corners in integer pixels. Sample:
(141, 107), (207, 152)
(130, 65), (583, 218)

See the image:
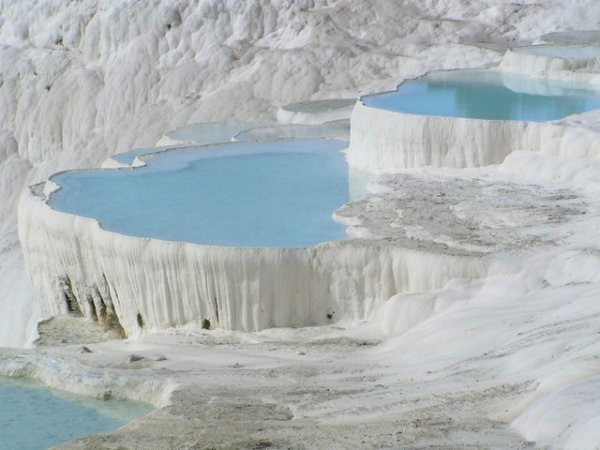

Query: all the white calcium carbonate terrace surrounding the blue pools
(5, 0), (600, 449)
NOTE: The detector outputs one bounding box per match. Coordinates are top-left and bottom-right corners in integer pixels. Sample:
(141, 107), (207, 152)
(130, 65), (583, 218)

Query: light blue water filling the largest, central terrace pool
(51, 140), (349, 247)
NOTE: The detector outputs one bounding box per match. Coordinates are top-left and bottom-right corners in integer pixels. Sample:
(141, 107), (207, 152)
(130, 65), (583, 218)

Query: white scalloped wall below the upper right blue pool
(347, 96), (567, 172)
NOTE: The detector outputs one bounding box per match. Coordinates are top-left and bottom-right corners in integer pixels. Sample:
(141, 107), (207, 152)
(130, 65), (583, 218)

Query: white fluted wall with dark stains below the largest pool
(18, 185), (505, 336)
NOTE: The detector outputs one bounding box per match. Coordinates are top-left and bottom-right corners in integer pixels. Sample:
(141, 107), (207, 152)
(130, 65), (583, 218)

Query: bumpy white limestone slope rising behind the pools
(7, 0), (598, 346)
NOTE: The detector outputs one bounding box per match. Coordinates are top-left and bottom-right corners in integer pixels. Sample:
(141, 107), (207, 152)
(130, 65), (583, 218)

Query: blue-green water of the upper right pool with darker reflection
(363, 70), (600, 122)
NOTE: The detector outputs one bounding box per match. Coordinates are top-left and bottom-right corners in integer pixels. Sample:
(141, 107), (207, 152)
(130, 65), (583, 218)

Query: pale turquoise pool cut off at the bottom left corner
(0, 377), (150, 450)
